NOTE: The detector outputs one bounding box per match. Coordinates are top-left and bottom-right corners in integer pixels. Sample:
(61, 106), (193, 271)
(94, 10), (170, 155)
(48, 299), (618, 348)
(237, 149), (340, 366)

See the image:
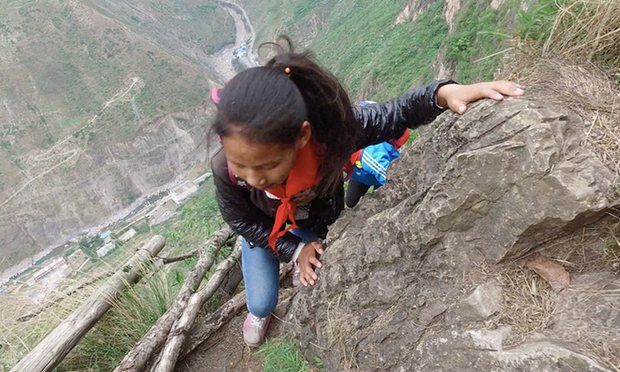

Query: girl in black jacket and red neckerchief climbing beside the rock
(211, 43), (523, 346)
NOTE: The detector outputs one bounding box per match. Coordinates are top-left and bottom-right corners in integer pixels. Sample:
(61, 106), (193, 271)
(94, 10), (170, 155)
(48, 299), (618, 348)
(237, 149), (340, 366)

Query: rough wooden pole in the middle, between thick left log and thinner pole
(114, 225), (233, 372)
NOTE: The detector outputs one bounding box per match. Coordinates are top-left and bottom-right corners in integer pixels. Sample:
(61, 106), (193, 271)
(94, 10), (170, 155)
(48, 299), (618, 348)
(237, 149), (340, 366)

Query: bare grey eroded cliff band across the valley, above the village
(0, 106), (207, 279)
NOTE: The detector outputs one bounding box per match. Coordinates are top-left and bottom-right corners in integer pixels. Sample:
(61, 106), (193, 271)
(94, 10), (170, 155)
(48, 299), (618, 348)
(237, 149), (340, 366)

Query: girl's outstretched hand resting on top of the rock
(437, 81), (525, 114)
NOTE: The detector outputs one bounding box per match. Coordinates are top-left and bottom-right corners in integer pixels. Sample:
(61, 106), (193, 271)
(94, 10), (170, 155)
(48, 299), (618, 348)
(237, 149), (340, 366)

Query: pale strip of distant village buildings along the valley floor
(0, 172), (211, 302)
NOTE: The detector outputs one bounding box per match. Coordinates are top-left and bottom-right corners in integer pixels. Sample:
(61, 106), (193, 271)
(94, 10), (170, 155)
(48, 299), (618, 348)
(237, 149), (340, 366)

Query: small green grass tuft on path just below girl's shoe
(258, 338), (310, 372)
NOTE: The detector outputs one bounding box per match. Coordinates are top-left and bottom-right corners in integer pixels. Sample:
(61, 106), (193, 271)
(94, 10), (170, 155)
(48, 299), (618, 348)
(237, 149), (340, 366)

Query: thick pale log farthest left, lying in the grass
(11, 235), (165, 372)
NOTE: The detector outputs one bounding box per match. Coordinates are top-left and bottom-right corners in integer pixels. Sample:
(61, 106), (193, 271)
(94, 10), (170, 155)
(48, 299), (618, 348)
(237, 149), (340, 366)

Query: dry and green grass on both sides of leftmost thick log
(0, 237), (170, 371)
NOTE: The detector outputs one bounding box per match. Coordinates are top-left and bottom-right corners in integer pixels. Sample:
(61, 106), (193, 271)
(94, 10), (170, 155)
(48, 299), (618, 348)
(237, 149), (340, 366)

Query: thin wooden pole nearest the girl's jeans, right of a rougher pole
(152, 244), (241, 372)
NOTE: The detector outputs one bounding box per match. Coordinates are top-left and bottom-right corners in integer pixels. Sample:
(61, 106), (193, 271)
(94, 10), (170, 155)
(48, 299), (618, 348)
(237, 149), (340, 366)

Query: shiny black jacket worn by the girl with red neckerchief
(211, 80), (453, 262)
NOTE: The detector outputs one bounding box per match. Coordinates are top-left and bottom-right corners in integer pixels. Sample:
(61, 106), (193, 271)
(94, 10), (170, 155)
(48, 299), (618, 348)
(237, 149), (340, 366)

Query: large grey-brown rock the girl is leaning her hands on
(289, 99), (620, 371)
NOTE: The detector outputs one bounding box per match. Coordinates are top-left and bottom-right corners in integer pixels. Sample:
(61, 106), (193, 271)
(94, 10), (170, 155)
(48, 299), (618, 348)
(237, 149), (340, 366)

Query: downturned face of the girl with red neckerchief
(222, 121), (311, 190)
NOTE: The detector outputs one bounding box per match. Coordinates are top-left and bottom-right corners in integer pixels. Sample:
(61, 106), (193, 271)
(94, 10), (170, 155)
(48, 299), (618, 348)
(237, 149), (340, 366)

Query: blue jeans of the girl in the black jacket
(241, 228), (318, 318)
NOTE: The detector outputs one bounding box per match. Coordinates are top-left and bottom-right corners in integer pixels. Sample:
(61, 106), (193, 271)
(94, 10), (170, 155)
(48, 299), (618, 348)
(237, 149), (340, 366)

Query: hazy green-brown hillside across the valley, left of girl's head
(0, 0), (234, 271)
